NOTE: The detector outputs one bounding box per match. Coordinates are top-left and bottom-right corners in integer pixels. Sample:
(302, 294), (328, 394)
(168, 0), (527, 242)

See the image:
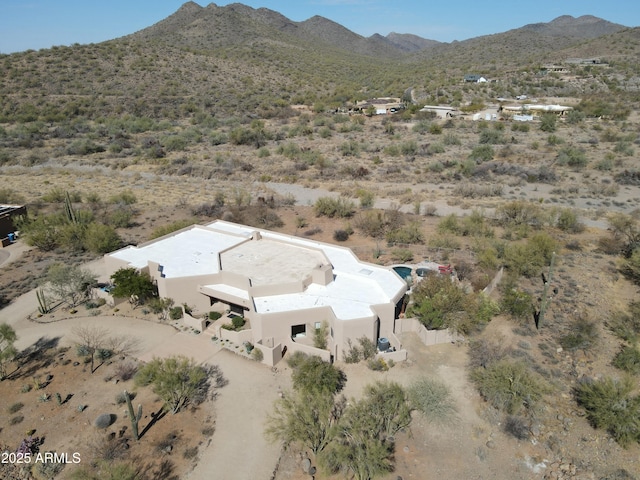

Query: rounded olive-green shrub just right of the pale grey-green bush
(471, 360), (549, 415)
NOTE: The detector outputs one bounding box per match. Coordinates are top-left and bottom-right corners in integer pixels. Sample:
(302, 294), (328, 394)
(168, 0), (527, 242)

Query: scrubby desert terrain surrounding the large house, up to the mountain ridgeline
(0, 2), (640, 480)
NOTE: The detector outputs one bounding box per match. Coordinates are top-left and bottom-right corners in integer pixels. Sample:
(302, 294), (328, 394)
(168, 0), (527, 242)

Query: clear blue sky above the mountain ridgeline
(0, 0), (640, 54)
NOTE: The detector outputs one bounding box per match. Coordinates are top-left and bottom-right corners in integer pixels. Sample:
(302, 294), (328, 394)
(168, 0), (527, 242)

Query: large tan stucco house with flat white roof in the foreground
(105, 220), (407, 365)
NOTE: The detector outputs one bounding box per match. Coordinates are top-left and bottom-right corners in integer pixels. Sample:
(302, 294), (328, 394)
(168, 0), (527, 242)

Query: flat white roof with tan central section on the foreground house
(111, 220), (407, 319)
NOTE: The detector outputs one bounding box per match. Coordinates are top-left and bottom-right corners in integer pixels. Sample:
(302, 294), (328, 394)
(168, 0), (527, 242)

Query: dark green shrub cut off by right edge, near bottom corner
(575, 377), (640, 447)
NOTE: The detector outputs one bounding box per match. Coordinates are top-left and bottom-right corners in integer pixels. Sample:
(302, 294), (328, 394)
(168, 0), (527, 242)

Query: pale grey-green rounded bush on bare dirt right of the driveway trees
(407, 378), (456, 424)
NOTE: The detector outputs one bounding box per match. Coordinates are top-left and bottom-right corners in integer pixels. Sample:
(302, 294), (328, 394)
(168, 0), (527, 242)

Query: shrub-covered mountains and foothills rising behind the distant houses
(0, 2), (640, 122)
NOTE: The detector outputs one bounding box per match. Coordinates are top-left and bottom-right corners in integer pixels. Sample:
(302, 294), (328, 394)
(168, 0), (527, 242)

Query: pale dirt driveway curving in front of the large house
(0, 252), (289, 480)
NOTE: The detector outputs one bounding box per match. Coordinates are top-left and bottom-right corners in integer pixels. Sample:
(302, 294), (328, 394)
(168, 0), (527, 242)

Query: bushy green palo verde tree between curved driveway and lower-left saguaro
(135, 355), (213, 414)
